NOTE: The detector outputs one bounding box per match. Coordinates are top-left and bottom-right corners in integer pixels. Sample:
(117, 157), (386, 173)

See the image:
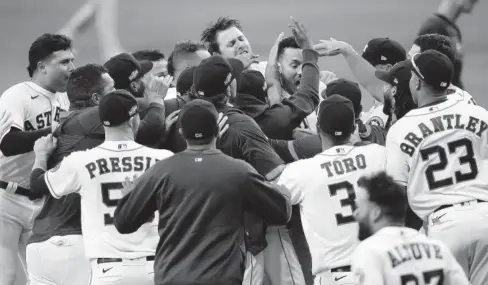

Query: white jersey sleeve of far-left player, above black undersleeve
(0, 86), (26, 133)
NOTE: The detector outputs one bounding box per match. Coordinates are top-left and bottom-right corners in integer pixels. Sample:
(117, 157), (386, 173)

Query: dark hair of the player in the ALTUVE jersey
(358, 171), (408, 222)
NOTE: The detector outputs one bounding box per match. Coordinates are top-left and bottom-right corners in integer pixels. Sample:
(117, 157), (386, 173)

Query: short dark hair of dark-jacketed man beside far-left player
(66, 64), (108, 102)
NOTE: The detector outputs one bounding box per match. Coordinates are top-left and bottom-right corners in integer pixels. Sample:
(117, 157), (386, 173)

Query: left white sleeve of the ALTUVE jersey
(352, 243), (386, 285)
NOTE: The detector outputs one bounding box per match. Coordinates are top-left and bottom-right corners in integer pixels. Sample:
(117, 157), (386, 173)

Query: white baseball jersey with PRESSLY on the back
(44, 141), (172, 259)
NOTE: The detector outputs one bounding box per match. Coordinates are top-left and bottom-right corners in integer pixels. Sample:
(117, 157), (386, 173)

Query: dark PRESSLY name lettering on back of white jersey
(85, 156), (159, 179)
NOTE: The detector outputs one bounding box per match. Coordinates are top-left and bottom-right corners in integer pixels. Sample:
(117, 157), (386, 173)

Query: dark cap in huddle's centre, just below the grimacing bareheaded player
(193, 55), (244, 97)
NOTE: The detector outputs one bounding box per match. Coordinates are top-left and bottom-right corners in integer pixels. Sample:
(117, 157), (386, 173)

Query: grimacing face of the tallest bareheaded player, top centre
(216, 27), (252, 58)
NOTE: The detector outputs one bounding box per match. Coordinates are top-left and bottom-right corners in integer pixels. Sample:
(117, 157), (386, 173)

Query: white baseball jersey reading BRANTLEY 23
(386, 100), (488, 220)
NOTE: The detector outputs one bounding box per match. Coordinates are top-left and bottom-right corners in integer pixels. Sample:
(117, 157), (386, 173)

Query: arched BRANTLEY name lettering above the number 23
(400, 114), (488, 157)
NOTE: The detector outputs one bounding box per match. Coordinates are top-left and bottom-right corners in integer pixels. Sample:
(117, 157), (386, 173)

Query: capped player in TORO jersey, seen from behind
(278, 95), (386, 285)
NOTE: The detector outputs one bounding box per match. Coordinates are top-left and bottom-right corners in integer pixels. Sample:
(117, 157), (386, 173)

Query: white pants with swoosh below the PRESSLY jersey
(90, 257), (154, 285)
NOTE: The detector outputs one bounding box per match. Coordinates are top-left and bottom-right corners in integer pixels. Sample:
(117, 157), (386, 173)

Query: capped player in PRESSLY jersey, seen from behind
(31, 90), (172, 285)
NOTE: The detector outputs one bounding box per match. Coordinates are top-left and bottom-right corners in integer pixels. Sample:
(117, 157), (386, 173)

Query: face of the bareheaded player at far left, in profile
(44, 50), (75, 92)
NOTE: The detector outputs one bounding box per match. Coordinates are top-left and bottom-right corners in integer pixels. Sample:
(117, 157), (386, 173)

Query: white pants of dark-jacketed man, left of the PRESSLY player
(27, 235), (91, 285)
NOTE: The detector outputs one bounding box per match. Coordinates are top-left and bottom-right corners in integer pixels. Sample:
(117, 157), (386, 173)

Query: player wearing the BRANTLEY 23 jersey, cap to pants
(386, 50), (488, 285)
